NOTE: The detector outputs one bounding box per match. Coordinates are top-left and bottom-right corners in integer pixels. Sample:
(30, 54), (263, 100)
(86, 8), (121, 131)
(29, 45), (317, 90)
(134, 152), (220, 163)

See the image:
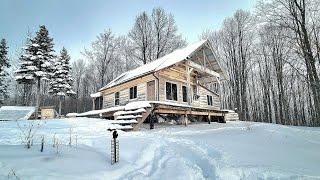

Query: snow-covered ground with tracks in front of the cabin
(0, 118), (320, 180)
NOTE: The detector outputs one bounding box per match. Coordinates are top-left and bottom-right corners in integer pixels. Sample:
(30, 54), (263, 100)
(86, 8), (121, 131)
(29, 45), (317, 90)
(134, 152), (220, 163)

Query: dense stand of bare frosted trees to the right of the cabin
(201, 0), (320, 126)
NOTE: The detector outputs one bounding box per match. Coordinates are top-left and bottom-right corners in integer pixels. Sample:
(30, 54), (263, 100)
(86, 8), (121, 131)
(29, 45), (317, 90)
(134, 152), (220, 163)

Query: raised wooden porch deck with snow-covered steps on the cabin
(100, 101), (228, 130)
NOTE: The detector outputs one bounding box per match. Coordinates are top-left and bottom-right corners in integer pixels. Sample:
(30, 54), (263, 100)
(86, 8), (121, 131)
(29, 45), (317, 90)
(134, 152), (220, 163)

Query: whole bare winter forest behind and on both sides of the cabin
(0, 0), (320, 126)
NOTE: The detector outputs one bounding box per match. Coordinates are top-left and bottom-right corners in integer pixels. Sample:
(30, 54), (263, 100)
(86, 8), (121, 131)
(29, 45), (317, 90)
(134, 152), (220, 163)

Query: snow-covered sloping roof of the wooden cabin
(99, 40), (207, 91)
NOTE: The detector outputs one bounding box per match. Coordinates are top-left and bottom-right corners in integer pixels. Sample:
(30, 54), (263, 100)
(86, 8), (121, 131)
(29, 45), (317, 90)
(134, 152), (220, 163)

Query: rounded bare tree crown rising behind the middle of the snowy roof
(128, 8), (186, 64)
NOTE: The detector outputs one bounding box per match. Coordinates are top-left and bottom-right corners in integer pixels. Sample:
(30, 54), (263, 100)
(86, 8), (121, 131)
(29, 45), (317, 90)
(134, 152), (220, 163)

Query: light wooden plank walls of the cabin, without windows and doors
(102, 65), (220, 110)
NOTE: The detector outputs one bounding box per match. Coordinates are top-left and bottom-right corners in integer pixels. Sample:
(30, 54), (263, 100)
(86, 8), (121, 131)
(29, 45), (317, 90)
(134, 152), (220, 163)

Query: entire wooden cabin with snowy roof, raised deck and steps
(87, 40), (232, 129)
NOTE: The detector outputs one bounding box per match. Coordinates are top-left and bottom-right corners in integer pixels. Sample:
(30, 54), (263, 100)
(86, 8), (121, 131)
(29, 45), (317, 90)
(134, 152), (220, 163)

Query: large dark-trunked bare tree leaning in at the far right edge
(259, 0), (320, 125)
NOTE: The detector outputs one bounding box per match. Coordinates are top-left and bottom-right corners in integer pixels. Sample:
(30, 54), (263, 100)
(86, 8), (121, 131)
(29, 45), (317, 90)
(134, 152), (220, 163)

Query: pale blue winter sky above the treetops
(0, 0), (255, 60)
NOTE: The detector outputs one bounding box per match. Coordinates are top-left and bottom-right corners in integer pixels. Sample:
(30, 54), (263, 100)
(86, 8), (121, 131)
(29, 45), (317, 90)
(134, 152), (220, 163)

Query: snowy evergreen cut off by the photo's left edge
(0, 39), (10, 104)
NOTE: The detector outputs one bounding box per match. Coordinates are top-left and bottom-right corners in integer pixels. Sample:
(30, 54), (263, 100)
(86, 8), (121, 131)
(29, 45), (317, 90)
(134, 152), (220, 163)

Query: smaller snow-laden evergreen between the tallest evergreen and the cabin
(49, 47), (75, 116)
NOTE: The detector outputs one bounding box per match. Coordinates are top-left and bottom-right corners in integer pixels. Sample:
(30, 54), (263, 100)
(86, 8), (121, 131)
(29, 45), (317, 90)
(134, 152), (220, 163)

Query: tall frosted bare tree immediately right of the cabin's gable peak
(205, 10), (252, 120)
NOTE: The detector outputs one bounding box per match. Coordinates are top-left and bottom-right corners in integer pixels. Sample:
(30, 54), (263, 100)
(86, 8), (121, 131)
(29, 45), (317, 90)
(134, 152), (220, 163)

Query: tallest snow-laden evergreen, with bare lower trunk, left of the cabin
(16, 25), (55, 117)
